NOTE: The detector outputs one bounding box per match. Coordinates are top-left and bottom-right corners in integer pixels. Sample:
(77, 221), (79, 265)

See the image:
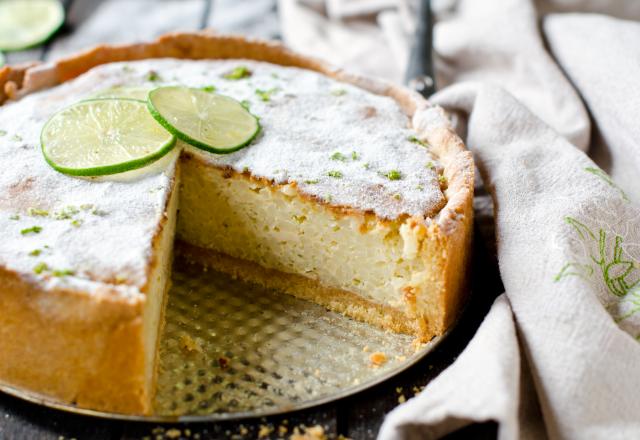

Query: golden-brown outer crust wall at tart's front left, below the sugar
(0, 268), (148, 413)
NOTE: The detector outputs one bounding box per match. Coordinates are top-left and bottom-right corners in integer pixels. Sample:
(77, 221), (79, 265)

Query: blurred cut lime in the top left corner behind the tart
(0, 0), (64, 50)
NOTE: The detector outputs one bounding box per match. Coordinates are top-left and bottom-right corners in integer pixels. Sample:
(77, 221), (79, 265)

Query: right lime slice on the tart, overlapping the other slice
(147, 86), (260, 154)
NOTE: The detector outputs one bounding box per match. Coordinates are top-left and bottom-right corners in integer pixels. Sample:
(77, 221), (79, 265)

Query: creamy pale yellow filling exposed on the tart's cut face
(177, 159), (427, 307)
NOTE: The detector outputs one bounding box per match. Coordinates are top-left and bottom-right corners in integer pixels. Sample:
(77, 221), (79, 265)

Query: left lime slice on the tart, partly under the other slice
(40, 99), (176, 176)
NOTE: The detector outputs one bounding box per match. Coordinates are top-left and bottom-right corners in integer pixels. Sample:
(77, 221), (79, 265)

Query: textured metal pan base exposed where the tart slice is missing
(0, 260), (442, 422)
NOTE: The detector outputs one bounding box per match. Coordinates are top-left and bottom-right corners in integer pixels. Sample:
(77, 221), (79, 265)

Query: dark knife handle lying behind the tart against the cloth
(405, 0), (436, 98)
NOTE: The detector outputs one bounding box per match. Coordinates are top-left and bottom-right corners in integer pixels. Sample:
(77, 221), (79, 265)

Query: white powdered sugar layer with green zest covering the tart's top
(0, 59), (445, 287)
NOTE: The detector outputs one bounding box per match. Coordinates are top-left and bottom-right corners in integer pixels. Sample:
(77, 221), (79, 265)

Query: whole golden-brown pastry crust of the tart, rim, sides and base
(0, 32), (474, 414)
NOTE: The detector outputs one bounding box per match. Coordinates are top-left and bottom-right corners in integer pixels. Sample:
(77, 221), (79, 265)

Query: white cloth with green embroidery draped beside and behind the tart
(281, 0), (640, 439)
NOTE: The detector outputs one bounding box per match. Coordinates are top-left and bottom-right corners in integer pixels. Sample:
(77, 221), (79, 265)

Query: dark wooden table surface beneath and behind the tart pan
(0, 0), (502, 440)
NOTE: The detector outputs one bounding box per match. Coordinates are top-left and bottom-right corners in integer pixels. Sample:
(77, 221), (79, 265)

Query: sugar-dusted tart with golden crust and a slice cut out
(0, 33), (474, 414)
